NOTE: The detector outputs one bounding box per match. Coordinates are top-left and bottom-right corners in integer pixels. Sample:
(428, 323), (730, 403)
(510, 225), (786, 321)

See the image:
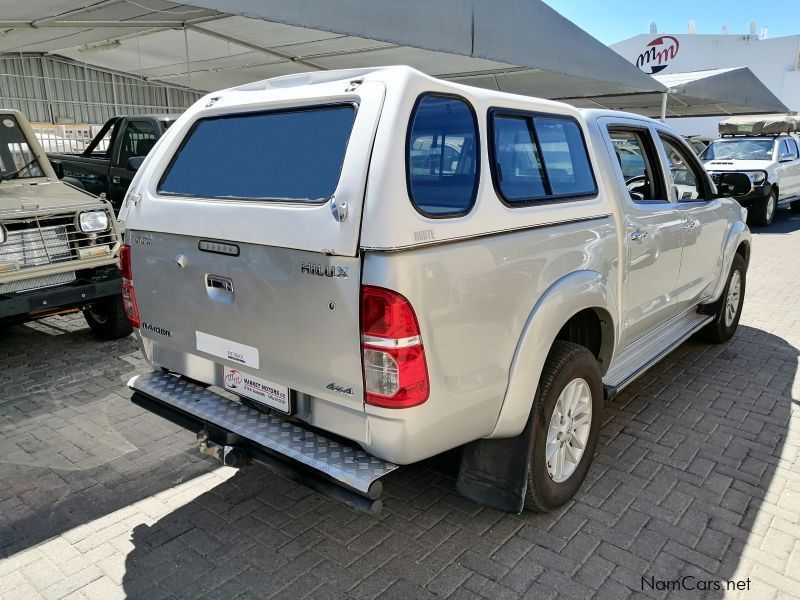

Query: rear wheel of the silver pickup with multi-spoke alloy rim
(525, 341), (603, 512)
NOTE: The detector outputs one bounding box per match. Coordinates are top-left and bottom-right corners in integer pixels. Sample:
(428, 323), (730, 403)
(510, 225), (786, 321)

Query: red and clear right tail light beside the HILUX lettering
(361, 285), (430, 408)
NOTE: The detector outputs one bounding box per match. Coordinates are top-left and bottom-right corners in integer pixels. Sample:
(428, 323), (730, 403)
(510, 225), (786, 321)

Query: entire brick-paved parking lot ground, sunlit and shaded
(0, 213), (800, 600)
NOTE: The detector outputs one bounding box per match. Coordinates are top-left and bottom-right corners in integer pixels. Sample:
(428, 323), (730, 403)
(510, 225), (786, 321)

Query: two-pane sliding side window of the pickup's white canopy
(492, 114), (597, 202)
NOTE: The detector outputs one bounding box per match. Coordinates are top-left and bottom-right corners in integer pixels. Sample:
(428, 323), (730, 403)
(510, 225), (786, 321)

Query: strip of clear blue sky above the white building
(544, 0), (800, 44)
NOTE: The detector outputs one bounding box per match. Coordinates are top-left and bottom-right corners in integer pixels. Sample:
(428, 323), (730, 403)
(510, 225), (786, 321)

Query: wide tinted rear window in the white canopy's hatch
(159, 105), (355, 202)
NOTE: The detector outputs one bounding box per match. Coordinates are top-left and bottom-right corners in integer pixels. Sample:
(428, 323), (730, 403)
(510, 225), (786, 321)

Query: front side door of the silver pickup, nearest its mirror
(658, 130), (728, 312)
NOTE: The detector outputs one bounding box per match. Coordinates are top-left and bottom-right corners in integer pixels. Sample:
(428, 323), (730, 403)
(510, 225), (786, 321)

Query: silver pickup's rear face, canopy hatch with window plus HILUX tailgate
(126, 82), (384, 410)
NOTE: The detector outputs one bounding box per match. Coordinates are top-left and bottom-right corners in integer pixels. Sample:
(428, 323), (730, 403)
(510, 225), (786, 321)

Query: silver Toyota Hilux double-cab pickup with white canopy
(120, 67), (751, 512)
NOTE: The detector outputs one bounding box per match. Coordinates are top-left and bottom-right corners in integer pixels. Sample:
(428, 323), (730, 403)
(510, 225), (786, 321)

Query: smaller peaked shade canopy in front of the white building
(565, 67), (789, 118)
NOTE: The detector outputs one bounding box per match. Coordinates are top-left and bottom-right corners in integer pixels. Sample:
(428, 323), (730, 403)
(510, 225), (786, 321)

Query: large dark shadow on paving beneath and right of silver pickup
(123, 326), (800, 598)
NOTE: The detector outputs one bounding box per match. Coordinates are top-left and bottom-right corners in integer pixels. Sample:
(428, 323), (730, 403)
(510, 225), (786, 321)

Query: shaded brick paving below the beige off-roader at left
(0, 316), (215, 556)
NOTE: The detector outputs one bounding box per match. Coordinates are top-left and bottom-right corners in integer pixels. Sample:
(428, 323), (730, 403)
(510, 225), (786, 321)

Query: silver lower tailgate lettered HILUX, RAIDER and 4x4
(126, 230), (363, 406)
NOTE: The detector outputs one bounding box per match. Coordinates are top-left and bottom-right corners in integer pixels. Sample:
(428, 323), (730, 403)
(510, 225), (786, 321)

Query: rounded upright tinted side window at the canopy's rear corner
(406, 96), (478, 217)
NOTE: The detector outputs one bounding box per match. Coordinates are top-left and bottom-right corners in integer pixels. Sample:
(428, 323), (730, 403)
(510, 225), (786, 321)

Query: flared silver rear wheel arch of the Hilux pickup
(489, 270), (618, 438)
